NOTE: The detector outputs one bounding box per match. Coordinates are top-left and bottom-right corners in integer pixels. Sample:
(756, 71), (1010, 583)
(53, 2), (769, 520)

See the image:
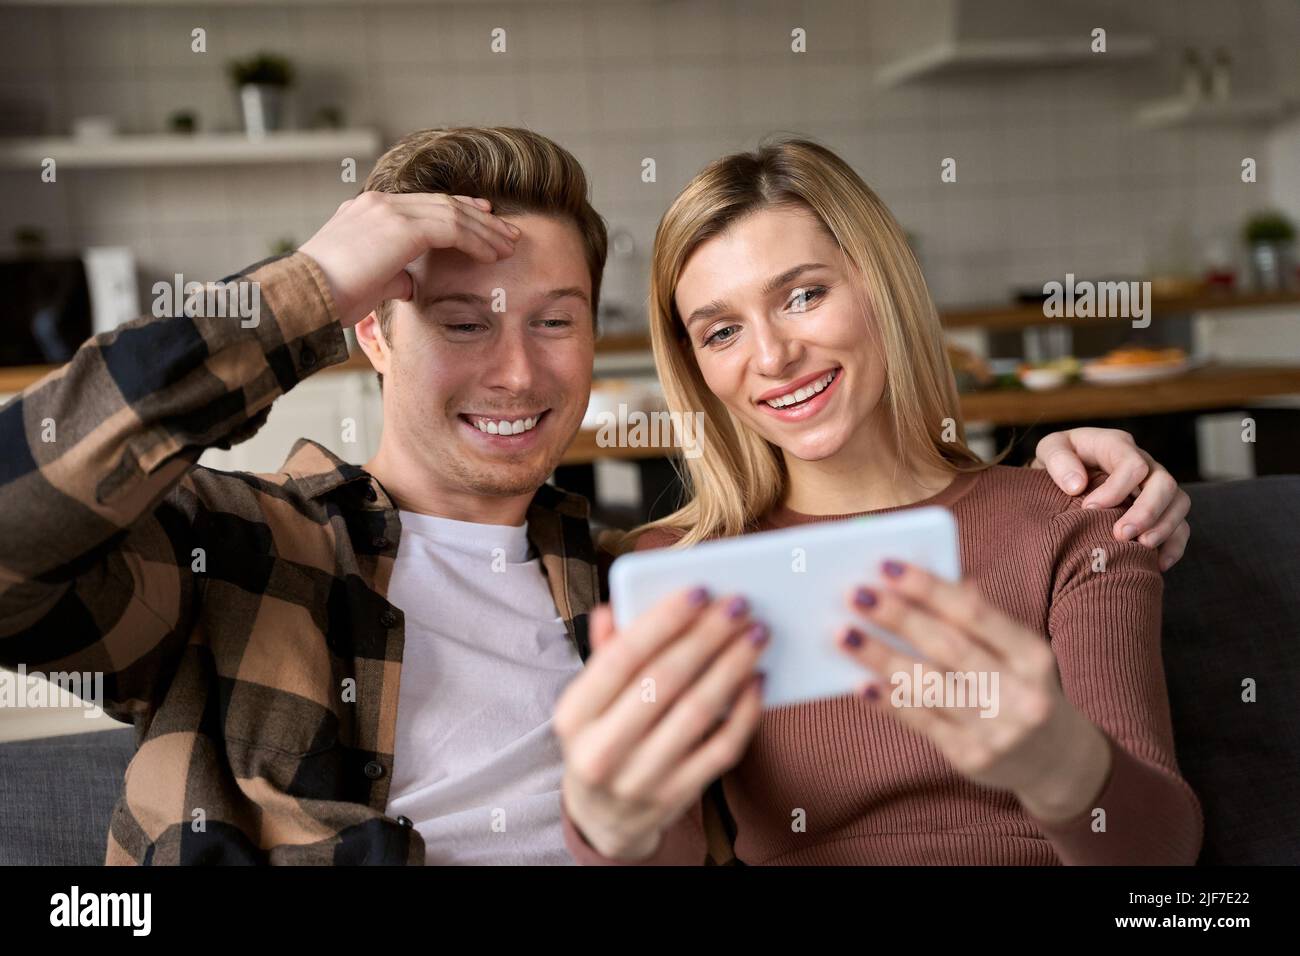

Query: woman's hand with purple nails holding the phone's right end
(840, 561), (1110, 822)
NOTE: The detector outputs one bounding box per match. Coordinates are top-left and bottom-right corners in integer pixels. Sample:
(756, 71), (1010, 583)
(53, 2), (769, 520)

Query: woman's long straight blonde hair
(624, 139), (992, 550)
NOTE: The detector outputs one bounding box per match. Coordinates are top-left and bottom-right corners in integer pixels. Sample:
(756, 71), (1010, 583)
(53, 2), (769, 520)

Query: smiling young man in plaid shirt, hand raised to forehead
(0, 129), (1186, 864)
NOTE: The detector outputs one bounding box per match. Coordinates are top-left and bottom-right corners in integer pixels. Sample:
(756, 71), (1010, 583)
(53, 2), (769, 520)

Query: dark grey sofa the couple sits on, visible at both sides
(0, 476), (1300, 865)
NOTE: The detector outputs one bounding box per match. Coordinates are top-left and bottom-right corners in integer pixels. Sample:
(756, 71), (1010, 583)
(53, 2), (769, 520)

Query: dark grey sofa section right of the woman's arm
(1162, 475), (1300, 865)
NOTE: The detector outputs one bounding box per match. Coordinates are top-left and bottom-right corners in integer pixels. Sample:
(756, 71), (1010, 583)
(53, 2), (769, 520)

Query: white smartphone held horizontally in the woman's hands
(610, 507), (961, 708)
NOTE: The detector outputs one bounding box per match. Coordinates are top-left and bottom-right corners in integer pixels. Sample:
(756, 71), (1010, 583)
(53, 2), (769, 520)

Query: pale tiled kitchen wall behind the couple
(0, 0), (1300, 316)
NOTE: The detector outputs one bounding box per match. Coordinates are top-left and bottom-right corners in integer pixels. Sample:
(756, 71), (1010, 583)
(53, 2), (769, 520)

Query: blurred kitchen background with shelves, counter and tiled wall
(0, 0), (1300, 538)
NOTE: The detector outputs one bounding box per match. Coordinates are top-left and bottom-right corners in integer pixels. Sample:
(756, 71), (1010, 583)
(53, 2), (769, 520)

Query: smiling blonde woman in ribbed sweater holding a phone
(555, 140), (1201, 864)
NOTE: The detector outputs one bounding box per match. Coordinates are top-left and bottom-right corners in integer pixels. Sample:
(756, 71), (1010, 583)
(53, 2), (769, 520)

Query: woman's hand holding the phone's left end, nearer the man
(555, 588), (768, 860)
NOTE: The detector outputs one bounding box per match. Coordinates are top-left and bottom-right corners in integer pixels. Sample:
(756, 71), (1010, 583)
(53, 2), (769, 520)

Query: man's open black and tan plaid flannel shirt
(0, 252), (601, 864)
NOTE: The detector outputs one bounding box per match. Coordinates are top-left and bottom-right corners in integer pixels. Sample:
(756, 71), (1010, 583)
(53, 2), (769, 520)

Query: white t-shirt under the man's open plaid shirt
(387, 511), (582, 864)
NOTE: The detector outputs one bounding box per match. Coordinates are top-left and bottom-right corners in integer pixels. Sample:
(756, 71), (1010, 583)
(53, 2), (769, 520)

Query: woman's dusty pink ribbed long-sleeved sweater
(566, 466), (1201, 865)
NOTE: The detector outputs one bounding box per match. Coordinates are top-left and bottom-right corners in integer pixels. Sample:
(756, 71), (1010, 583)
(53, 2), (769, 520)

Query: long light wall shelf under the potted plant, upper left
(0, 129), (380, 169)
